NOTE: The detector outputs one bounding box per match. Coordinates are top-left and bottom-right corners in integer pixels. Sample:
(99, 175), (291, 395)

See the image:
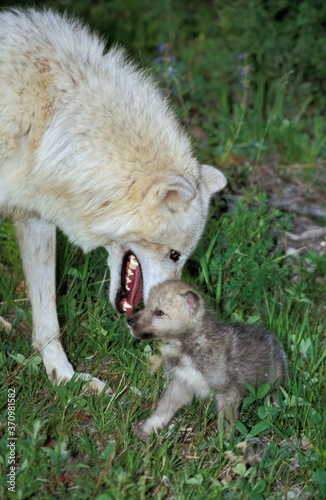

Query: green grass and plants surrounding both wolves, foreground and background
(0, 0), (326, 500)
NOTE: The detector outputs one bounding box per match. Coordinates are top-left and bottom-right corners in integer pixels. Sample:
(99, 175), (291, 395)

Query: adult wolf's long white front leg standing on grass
(15, 218), (109, 392)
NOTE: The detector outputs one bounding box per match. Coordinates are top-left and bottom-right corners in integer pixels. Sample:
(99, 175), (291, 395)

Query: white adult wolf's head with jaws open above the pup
(107, 165), (226, 316)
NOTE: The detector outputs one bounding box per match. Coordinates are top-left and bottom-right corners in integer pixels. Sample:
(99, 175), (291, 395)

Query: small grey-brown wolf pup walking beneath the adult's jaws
(127, 280), (287, 438)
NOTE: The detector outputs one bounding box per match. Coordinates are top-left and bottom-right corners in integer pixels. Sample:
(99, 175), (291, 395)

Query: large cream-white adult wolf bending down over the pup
(0, 9), (226, 391)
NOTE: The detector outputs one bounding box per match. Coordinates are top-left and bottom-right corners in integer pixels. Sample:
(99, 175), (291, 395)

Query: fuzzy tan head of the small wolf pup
(127, 280), (204, 340)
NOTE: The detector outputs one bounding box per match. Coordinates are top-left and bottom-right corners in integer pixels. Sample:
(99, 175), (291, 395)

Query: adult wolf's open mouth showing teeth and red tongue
(117, 250), (143, 316)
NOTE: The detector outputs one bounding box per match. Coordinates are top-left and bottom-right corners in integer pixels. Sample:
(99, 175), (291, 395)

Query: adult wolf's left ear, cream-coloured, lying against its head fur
(145, 174), (195, 208)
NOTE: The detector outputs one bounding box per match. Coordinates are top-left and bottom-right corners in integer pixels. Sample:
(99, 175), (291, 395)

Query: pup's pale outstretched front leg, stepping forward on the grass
(136, 380), (194, 439)
